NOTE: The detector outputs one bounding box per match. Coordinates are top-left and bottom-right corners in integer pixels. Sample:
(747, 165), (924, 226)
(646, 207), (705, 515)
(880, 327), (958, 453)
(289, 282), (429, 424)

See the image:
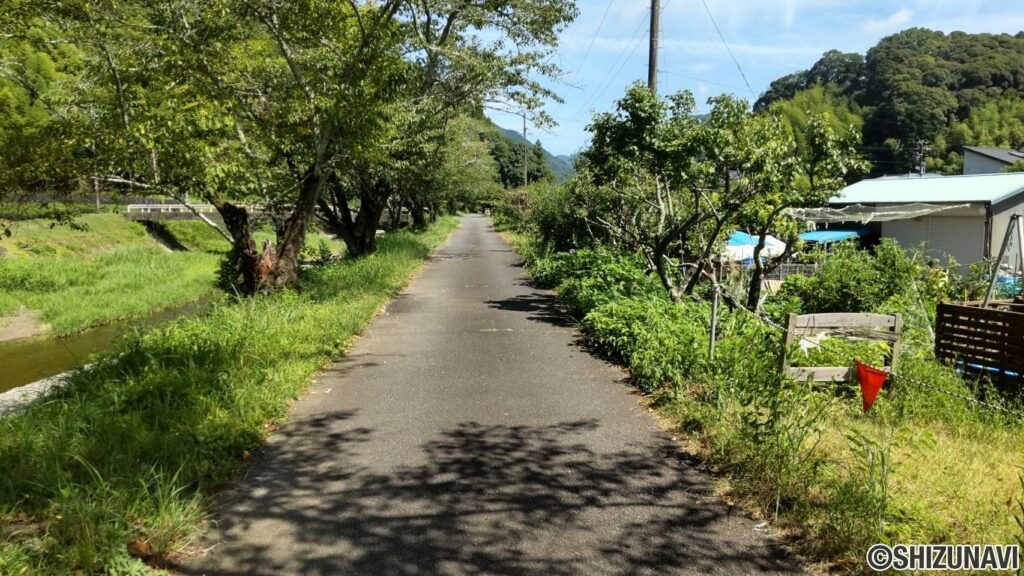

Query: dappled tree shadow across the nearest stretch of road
(178, 415), (791, 576)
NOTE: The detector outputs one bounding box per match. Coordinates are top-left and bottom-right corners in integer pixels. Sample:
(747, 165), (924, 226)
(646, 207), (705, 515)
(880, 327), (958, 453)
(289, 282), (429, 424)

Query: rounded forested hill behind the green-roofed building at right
(755, 28), (1024, 174)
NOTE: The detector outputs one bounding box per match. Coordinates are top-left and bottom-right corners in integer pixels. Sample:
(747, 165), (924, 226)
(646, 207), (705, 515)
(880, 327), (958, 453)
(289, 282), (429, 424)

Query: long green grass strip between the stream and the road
(0, 218), (455, 574)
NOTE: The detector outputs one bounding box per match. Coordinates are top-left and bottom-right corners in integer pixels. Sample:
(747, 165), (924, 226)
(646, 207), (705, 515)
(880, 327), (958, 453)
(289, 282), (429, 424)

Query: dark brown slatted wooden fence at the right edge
(935, 299), (1024, 395)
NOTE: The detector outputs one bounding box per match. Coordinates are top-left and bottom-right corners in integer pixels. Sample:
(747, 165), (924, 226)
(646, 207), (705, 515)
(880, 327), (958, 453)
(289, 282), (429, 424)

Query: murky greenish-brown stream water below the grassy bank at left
(0, 300), (209, 393)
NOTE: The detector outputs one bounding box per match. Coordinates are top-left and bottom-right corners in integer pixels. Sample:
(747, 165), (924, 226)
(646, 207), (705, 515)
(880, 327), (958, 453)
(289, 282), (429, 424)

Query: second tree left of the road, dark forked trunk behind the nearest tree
(311, 0), (577, 255)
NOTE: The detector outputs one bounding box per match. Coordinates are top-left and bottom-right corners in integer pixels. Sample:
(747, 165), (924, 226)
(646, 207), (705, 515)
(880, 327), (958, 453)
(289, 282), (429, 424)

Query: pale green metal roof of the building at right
(829, 172), (1024, 204)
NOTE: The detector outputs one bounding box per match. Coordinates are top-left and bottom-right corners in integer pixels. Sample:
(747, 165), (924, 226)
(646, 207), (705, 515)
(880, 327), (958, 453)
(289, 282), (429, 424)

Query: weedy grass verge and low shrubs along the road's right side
(506, 234), (1024, 574)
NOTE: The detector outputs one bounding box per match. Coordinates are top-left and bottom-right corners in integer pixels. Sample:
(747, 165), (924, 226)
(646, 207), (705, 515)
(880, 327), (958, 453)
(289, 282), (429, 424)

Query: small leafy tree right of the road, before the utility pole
(570, 84), (860, 308)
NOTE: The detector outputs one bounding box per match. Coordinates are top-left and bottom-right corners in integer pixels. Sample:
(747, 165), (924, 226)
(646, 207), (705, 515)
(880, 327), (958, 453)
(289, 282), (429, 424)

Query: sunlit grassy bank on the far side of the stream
(0, 214), (223, 336)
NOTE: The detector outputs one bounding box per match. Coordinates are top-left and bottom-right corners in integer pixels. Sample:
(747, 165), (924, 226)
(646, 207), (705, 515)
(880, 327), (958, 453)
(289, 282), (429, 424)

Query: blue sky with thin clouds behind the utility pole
(487, 0), (1024, 155)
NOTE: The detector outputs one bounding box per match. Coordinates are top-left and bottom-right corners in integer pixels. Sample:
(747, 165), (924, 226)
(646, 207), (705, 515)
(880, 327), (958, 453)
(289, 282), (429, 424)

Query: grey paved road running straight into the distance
(182, 216), (795, 576)
